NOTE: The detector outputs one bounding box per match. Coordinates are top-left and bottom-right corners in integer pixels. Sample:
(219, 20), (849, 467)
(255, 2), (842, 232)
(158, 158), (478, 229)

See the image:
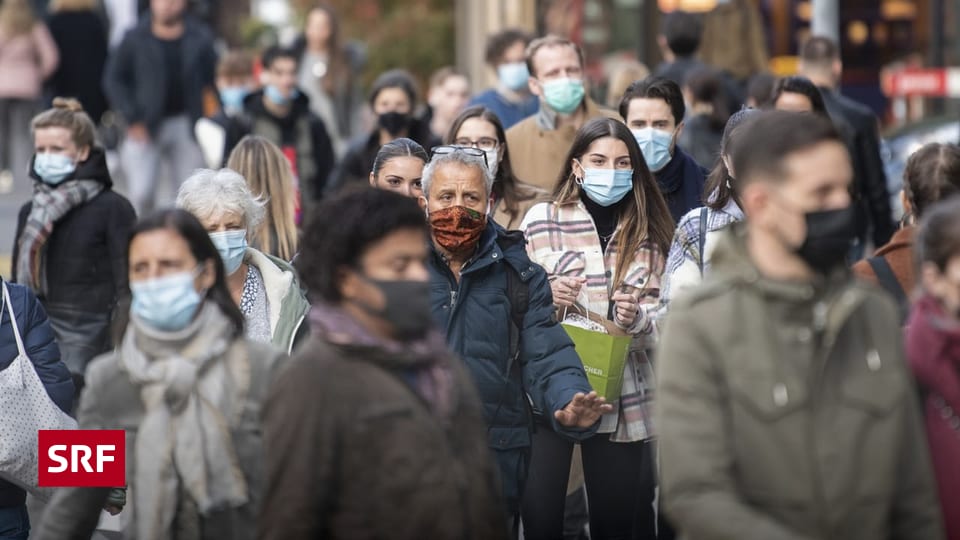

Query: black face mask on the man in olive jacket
(796, 206), (857, 274)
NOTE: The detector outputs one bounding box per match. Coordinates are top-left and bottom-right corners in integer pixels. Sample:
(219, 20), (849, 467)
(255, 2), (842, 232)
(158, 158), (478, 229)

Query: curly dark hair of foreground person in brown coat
(294, 186), (429, 303)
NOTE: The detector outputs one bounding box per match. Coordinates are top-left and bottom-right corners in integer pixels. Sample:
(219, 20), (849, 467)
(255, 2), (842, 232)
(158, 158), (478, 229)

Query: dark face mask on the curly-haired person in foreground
(353, 274), (433, 341)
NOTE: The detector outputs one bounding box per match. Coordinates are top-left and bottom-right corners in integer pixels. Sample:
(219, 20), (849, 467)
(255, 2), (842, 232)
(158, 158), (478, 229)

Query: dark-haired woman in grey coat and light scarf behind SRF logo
(31, 209), (286, 540)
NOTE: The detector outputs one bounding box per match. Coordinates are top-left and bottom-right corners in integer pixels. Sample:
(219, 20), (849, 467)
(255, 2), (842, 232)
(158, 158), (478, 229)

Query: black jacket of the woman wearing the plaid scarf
(12, 147), (136, 374)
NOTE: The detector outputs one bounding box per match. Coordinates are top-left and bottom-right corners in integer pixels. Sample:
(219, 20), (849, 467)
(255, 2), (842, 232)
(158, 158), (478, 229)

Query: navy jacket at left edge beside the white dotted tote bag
(0, 279), (74, 508)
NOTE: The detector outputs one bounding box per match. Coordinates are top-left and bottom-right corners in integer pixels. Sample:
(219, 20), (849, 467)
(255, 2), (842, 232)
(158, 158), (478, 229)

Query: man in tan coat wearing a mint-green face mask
(507, 35), (614, 193)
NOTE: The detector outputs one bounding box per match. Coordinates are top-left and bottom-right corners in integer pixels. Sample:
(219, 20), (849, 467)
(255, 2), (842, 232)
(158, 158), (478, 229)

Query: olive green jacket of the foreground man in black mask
(655, 224), (943, 540)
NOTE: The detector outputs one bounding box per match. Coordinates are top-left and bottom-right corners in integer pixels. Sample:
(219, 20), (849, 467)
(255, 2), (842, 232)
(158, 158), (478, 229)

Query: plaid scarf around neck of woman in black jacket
(17, 180), (104, 295)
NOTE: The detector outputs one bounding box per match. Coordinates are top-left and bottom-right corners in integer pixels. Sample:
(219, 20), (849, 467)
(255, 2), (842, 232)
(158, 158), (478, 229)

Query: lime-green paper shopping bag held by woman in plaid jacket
(561, 306), (633, 403)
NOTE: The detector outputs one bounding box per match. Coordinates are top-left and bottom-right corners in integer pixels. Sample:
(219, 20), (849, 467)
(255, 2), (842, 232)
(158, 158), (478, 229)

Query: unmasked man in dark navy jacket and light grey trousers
(103, 0), (217, 213)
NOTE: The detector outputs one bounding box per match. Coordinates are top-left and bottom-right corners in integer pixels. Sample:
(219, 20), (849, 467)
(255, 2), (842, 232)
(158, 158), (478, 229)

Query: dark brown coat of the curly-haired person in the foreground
(259, 335), (507, 540)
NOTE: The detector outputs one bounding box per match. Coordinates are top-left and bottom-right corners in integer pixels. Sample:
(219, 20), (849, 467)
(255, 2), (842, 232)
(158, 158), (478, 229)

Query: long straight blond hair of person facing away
(227, 135), (300, 261)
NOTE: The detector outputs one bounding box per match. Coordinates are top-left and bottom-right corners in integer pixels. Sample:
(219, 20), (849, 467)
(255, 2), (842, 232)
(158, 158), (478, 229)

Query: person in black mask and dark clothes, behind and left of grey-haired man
(330, 69), (440, 191)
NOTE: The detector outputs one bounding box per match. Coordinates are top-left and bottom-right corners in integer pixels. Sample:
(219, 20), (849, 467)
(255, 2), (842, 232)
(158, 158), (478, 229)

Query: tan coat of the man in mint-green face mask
(506, 98), (618, 193)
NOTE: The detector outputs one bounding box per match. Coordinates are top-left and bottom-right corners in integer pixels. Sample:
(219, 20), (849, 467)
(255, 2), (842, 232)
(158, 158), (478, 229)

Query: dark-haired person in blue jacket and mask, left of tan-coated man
(467, 28), (540, 129)
